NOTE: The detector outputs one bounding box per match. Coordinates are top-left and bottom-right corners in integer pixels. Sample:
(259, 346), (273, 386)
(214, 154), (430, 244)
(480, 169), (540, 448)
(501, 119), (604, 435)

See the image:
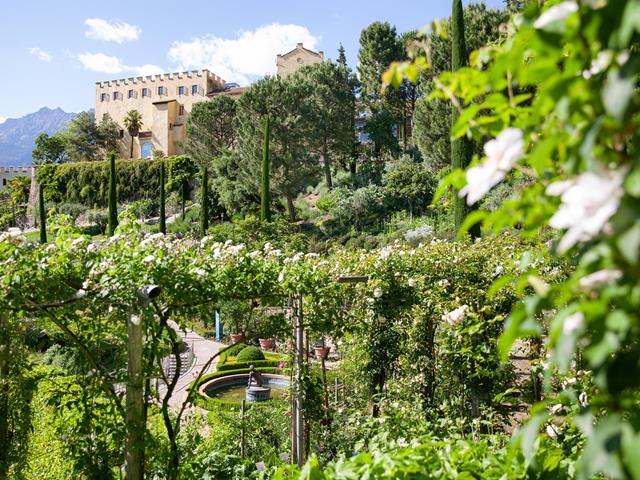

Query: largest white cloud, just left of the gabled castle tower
(168, 23), (320, 84)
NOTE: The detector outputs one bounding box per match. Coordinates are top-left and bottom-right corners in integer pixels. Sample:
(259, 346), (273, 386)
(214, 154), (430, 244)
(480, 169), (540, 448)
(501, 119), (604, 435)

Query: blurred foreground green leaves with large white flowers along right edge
(384, 0), (640, 478)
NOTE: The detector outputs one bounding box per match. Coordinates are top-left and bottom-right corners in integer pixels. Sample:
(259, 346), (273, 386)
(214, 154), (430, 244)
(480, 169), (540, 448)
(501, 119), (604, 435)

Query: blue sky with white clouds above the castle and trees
(0, 0), (503, 121)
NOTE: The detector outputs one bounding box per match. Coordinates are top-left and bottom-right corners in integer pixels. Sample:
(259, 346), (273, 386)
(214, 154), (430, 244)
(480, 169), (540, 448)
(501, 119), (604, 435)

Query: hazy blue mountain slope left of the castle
(0, 107), (76, 167)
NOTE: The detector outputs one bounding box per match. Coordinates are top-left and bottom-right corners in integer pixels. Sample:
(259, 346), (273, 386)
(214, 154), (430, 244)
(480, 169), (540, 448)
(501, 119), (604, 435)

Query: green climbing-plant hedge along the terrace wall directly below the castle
(38, 156), (192, 207)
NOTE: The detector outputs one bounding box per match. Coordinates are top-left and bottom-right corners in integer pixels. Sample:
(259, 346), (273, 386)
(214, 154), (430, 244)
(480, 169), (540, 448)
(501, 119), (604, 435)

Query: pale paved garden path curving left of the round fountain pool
(159, 321), (226, 406)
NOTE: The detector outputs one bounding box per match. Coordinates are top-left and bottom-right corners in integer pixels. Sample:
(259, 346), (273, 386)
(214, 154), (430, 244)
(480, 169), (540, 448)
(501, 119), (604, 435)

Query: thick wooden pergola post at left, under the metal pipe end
(125, 315), (145, 480)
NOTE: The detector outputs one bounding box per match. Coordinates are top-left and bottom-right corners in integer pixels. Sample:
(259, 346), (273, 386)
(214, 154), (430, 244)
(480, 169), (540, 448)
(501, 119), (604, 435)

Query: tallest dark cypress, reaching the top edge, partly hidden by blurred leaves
(451, 0), (480, 238)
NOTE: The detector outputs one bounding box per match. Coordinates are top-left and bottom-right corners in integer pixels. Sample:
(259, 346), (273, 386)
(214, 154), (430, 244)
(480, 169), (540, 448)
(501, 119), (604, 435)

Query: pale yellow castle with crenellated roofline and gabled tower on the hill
(95, 43), (324, 158)
